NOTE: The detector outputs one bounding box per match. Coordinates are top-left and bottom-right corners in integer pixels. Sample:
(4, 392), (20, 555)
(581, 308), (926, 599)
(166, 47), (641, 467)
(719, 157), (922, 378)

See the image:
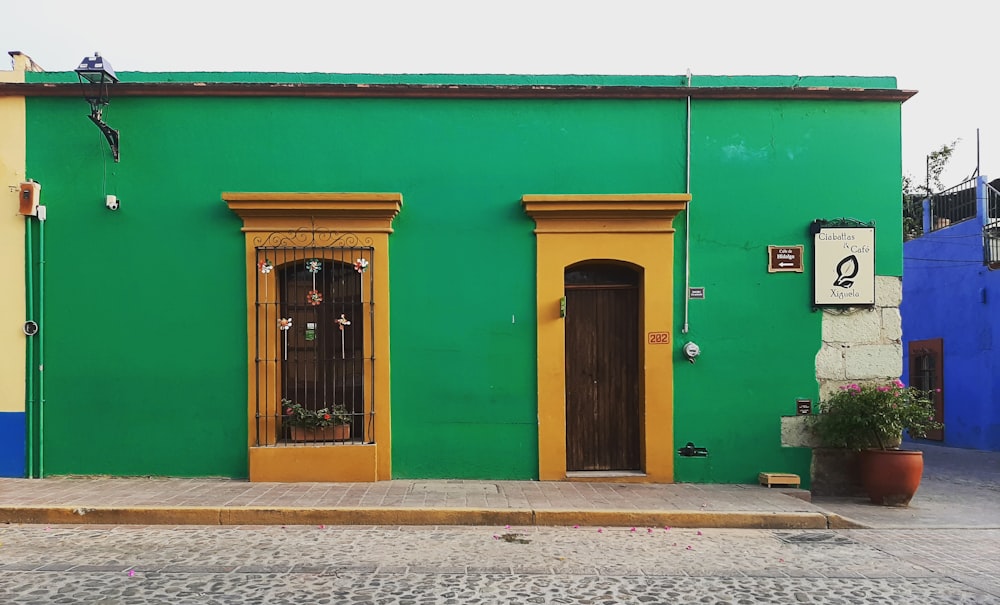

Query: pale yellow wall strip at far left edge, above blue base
(0, 59), (26, 412)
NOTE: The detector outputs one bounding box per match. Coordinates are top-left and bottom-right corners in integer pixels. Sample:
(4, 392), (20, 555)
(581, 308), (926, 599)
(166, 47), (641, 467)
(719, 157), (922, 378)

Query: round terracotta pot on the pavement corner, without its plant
(860, 449), (924, 506)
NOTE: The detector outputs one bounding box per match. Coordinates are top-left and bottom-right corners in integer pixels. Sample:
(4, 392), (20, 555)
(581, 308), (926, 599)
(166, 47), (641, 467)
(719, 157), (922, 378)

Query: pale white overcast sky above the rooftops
(0, 0), (1000, 186)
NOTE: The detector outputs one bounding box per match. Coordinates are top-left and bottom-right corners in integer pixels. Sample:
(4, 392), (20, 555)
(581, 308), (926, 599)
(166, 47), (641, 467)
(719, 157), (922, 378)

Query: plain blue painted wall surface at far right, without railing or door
(900, 177), (1000, 451)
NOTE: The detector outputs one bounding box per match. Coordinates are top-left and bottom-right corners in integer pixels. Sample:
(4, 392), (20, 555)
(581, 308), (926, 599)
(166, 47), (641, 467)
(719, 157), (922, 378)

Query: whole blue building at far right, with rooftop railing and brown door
(900, 176), (1000, 451)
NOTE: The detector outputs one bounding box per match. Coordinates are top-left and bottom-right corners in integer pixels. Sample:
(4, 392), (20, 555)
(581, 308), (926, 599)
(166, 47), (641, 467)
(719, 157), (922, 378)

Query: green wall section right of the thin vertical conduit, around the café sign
(674, 101), (902, 483)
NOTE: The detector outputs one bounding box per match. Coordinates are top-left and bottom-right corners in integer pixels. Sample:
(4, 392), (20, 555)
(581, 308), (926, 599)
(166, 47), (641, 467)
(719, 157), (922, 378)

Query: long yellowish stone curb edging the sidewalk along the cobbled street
(0, 506), (867, 529)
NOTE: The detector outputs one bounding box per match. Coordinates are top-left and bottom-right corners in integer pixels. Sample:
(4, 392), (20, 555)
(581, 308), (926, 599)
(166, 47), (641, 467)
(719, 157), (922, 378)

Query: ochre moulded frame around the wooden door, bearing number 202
(521, 193), (691, 483)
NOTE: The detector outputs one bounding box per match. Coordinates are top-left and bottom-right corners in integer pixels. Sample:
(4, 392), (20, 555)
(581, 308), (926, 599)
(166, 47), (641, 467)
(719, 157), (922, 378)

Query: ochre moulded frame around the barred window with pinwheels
(222, 193), (403, 482)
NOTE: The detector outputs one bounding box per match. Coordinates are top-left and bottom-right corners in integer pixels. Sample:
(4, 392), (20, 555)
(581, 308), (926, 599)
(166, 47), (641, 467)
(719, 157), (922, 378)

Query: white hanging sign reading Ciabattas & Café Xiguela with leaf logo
(813, 221), (875, 306)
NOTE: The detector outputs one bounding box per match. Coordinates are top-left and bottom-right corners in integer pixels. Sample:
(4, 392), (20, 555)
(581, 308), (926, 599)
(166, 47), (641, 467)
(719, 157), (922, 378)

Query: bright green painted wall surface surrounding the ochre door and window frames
(28, 74), (901, 482)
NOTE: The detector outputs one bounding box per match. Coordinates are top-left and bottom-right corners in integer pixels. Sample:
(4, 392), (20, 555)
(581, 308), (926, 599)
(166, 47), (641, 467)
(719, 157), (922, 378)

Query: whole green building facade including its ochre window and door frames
(0, 68), (911, 483)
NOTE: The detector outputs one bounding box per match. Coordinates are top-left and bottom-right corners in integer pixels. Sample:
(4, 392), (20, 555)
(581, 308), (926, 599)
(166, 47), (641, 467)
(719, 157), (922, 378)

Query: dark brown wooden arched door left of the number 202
(566, 266), (641, 471)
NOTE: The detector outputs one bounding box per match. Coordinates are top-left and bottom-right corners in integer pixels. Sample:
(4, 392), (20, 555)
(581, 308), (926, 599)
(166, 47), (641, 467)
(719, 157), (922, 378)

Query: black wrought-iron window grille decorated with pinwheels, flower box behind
(254, 231), (375, 446)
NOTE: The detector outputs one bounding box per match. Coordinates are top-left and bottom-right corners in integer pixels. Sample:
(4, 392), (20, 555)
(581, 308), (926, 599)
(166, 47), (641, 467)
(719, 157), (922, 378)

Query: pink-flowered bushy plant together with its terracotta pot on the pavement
(813, 379), (943, 506)
